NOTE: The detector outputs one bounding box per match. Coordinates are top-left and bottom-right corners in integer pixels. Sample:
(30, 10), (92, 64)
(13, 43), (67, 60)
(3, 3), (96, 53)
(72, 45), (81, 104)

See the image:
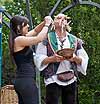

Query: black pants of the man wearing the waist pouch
(46, 82), (79, 104)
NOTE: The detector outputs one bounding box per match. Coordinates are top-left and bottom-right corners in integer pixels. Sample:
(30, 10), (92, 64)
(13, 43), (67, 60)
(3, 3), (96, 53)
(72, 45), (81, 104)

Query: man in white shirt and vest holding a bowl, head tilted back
(35, 14), (88, 104)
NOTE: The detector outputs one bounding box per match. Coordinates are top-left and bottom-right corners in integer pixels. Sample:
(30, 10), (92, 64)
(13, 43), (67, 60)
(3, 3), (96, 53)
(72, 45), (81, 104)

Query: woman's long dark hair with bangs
(9, 16), (29, 59)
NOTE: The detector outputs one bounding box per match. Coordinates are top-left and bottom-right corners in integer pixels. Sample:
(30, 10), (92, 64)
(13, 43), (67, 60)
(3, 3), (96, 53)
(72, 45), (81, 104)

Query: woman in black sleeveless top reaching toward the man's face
(9, 16), (52, 104)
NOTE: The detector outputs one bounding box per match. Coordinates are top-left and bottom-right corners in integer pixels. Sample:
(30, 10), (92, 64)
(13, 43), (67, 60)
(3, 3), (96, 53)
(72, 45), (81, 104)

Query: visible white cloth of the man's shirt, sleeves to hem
(34, 32), (88, 86)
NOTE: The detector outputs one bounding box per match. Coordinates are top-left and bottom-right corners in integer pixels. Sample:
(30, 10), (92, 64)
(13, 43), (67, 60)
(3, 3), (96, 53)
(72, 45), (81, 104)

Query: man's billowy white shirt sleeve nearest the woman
(34, 42), (48, 71)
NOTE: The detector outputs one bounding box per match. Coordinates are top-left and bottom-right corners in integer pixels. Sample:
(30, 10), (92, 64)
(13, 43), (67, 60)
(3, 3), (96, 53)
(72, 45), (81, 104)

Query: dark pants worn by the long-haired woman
(14, 78), (39, 104)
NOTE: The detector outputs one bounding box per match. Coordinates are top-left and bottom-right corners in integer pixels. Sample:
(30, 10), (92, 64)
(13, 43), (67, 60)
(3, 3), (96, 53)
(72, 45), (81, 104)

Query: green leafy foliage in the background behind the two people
(2, 0), (100, 104)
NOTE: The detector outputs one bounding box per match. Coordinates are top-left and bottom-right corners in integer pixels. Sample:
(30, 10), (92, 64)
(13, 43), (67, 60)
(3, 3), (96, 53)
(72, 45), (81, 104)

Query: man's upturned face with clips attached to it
(54, 14), (67, 28)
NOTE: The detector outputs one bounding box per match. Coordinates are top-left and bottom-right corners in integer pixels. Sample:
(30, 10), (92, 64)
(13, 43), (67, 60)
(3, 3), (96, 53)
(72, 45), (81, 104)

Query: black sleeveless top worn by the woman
(14, 46), (35, 78)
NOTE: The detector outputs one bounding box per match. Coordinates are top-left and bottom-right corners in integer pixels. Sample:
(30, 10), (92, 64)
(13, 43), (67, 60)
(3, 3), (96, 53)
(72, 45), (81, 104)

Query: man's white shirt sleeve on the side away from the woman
(77, 47), (89, 75)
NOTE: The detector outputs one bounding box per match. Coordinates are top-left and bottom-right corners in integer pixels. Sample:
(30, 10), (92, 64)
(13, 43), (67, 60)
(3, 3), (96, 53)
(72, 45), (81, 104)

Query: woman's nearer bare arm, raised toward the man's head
(15, 16), (52, 47)
